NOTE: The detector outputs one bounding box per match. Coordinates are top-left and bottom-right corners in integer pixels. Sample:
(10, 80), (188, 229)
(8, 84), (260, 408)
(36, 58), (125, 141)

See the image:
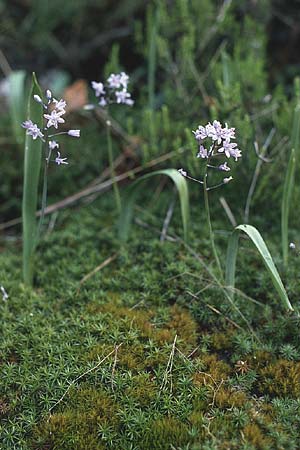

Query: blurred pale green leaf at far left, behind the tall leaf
(8, 70), (26, 146)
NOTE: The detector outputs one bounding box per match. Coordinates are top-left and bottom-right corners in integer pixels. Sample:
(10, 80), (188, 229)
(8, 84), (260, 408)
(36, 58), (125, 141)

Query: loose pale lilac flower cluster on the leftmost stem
(22, 89), (80, 165)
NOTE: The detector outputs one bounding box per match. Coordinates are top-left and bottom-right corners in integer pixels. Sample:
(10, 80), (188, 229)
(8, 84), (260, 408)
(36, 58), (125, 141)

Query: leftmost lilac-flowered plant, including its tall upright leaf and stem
(22, 74), (80, 285)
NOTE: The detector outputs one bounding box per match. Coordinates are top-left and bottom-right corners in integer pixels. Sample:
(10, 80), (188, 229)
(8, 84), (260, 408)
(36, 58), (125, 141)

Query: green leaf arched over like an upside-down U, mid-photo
(119, 169), (190, 241)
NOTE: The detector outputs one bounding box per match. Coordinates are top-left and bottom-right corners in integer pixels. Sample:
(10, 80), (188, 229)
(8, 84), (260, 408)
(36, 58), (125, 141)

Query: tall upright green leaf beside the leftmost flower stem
(19, 74), (43, 285)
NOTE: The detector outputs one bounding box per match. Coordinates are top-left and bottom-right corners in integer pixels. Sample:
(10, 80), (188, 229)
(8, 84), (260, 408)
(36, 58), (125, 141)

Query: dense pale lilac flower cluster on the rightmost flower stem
(193, 120), (242, 163)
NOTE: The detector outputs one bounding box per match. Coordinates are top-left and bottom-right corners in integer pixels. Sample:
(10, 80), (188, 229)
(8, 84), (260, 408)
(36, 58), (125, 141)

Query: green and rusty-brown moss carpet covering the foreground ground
(0, 195), (300, 450)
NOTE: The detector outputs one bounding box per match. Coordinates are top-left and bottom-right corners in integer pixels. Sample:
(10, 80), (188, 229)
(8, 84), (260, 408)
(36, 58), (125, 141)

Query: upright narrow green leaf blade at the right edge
(281, 149), (296, 267)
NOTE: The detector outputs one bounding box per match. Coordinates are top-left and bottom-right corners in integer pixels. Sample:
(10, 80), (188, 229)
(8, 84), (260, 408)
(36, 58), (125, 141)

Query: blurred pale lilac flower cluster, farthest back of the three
(91, 72), (134, 107)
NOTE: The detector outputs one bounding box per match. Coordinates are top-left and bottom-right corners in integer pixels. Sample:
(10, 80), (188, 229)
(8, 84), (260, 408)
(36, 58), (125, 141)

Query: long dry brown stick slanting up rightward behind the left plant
(0, 148), (185, 231)
